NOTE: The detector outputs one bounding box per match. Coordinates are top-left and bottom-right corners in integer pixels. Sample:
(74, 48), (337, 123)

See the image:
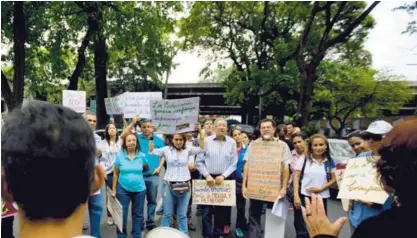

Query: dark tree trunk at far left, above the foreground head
(7, 2), (27, 111)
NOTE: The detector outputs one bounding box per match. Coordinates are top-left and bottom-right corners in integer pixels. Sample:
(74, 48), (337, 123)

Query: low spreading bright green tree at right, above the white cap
(313, 61), (413, 136)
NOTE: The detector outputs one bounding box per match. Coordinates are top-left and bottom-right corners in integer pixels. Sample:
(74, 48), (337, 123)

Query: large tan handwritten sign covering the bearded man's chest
(247, 141), (283, 202)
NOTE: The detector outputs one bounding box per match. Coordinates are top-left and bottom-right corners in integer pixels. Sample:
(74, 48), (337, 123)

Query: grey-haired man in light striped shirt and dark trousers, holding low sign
(196, 118), (237, 238)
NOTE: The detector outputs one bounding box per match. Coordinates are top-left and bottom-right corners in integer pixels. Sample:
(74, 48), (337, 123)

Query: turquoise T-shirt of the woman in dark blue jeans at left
(114, 151), (147, 192)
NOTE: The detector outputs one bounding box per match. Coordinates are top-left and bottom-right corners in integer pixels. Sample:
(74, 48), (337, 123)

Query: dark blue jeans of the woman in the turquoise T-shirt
(116, 183), (146, 238)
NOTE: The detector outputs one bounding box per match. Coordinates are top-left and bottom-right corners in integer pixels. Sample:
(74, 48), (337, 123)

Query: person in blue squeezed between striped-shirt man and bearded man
(228, 128), (247, 237)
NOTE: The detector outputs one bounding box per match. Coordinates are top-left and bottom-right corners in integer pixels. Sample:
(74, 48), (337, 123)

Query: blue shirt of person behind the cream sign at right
(349, 151), (383, 227)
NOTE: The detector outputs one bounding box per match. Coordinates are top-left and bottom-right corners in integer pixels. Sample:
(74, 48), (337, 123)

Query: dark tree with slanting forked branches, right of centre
(295, 1), (379, 125)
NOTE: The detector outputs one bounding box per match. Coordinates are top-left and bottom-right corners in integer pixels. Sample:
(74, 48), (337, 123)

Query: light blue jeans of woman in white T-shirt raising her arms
(161, 181), (191, 236)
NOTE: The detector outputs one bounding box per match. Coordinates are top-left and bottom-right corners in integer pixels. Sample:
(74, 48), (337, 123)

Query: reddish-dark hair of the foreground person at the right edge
(377, 120), (417, 207)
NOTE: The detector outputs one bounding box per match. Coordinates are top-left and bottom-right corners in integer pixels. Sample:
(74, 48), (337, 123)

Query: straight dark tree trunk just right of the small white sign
(94, 6), (109, 129)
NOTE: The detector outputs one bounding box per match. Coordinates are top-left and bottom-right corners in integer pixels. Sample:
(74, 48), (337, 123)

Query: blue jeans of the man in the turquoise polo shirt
(144, 175), (159, 227)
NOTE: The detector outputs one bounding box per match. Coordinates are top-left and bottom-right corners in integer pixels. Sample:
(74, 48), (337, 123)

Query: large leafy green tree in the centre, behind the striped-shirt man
(180, 2), (308, 124)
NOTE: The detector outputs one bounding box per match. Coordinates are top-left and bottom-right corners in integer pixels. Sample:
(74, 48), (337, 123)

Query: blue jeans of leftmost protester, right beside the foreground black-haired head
(88, 193), (104, 238)
